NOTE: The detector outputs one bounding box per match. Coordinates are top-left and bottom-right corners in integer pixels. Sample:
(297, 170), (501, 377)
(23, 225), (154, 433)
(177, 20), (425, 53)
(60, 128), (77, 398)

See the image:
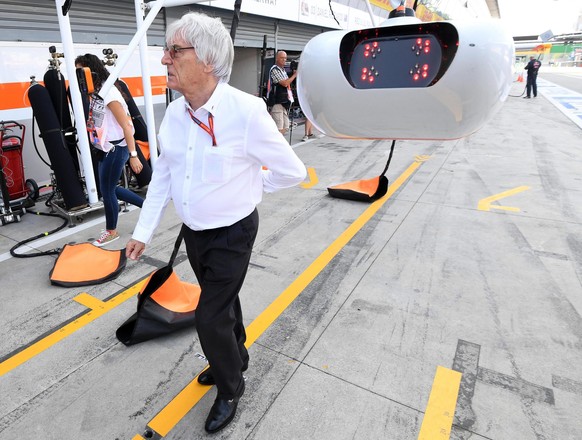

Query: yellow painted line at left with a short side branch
(0, 280), (145, 377)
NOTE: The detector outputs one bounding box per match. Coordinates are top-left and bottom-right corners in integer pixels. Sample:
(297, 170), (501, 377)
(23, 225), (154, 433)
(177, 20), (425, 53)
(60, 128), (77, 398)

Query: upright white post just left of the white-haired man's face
(135, 0), (161, 164)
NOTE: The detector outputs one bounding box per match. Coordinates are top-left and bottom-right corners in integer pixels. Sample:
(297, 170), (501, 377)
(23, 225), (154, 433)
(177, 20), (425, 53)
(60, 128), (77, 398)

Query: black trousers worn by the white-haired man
(183, 209), (259, 399)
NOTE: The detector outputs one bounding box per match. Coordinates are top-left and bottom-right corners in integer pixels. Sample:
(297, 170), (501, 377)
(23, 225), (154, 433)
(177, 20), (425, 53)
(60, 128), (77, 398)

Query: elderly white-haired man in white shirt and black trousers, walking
(126, 12), (307, 433)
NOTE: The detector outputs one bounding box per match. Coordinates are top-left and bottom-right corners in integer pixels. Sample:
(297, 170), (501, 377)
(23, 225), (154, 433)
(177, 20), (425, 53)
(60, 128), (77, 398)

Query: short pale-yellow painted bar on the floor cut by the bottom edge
(418, 366), (463, 440)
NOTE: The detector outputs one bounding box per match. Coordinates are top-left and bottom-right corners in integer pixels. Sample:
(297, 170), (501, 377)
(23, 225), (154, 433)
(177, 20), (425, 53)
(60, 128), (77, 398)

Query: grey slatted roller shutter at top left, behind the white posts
(0, 0), (165, 45)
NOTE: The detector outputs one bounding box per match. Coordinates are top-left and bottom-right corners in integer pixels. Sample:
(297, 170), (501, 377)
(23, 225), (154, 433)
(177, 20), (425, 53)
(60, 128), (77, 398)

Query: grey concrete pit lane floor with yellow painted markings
(0, 70), (582, 440)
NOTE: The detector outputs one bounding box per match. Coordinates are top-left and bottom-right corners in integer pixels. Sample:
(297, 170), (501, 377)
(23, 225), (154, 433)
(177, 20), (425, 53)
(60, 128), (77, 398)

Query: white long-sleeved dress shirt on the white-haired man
(133, 83), (307, 243)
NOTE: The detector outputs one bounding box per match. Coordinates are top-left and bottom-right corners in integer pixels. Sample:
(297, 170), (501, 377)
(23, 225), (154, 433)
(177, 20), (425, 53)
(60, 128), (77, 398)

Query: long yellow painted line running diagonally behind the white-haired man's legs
(148, 159), (426, 437)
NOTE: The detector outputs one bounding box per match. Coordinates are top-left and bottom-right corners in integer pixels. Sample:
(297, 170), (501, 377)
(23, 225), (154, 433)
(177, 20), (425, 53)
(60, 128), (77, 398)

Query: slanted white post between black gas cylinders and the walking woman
(55, 0), (99, 204)
